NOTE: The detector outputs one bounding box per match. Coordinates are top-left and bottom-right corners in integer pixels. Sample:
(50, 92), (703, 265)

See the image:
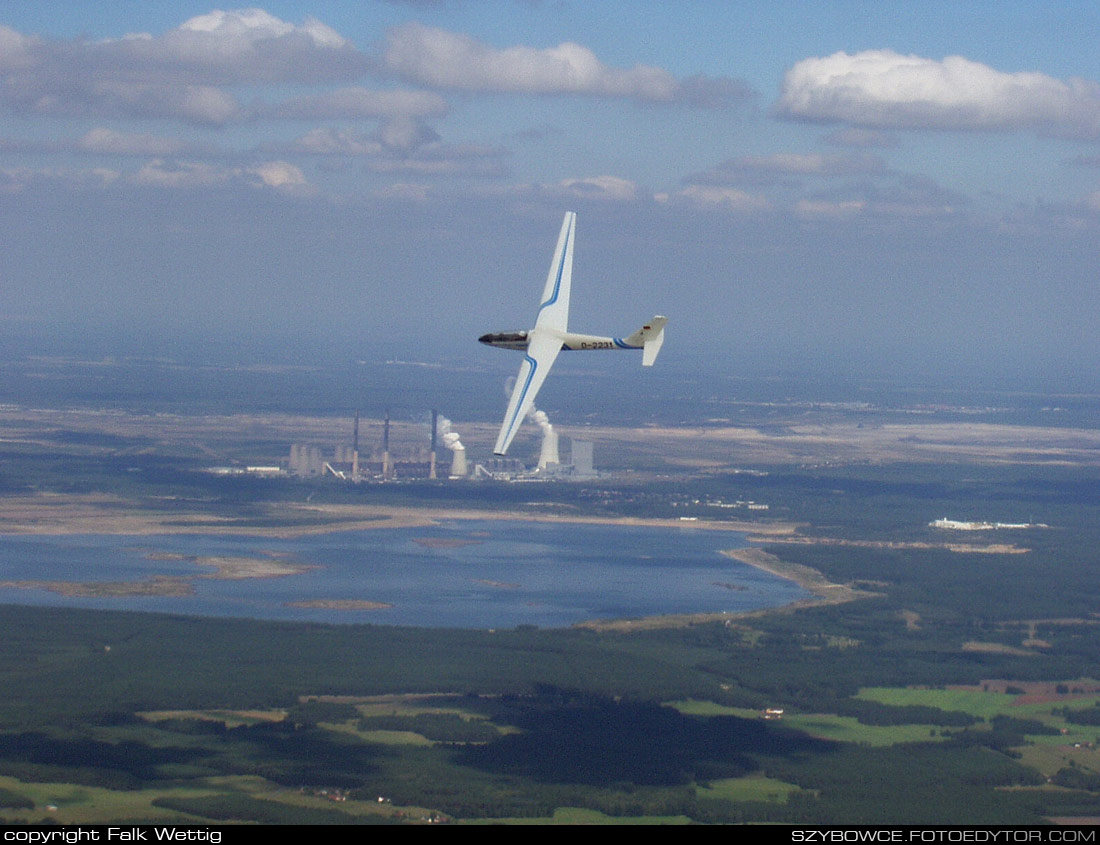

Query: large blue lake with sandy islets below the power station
(0, 520), (809, 628)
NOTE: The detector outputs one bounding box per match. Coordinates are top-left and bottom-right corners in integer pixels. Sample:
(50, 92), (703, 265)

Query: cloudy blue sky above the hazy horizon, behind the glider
(0, 0), (1100, 380)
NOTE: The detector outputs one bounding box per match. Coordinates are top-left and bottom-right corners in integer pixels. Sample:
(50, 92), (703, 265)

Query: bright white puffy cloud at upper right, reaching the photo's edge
(776, 50), (1100, 138)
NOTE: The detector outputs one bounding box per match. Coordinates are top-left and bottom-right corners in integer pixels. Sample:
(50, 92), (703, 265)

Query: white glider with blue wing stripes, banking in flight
(479, 211), (668, 454)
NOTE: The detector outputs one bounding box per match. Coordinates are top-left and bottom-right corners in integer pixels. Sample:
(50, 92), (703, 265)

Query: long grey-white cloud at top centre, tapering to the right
(382, 23), (749, 106)
